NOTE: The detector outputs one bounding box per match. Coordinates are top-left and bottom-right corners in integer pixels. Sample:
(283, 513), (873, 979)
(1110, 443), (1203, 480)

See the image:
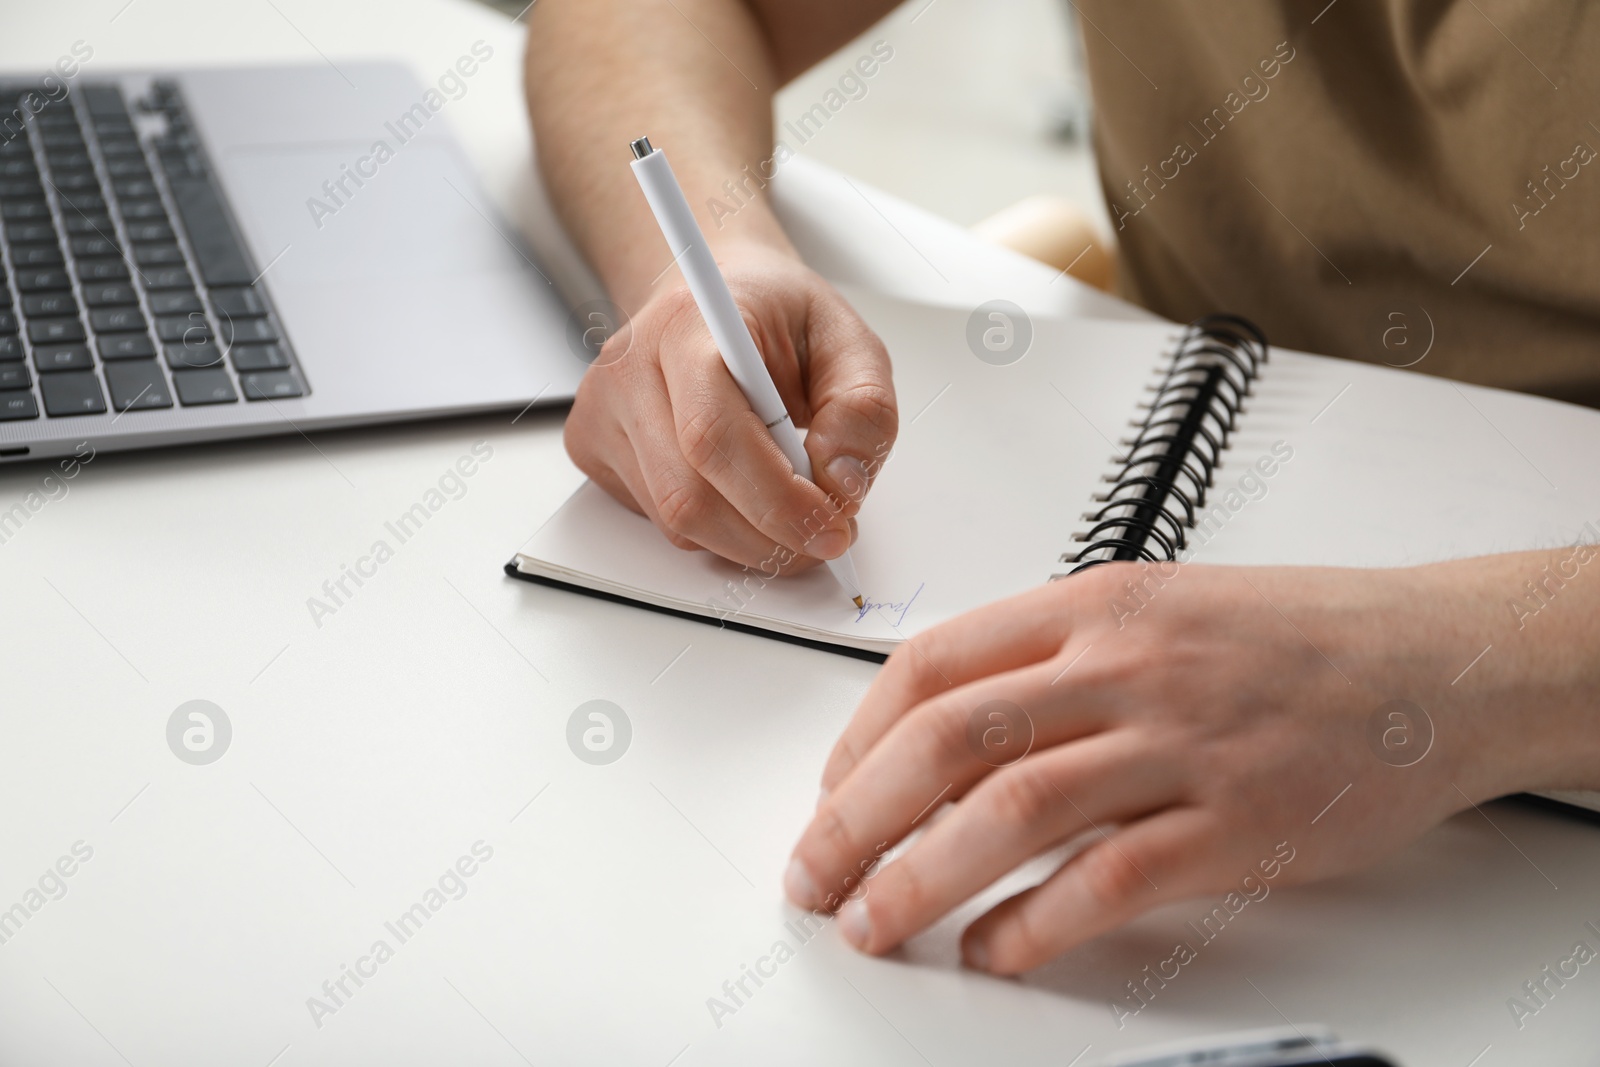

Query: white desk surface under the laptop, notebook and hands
(0, 0), (1600, 1067)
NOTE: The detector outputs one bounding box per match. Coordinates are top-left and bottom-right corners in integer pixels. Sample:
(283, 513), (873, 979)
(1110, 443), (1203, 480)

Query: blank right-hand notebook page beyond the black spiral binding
(1192, 350), (1600, 566)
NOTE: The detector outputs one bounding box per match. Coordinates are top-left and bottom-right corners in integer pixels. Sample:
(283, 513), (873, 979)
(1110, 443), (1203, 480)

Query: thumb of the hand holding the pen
(805, 288), (899, 515)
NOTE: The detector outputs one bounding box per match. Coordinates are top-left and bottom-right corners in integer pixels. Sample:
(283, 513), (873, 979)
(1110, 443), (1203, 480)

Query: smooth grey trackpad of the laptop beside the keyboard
(219, 139), (528, 285)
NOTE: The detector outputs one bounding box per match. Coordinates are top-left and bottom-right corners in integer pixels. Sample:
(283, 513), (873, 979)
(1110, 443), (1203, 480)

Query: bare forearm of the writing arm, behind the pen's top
(526, 0), (789, 310)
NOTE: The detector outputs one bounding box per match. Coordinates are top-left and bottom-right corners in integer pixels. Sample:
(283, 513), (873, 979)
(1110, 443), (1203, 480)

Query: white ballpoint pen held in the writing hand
(632, 138), (866, 608)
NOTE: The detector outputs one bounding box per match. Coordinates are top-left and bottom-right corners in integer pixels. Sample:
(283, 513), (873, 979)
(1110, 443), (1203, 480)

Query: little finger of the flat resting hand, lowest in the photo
(962, 808), (1226, 974)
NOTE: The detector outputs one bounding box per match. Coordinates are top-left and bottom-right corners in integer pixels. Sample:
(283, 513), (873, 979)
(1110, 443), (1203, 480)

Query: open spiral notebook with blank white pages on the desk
(506, 283), (1600, 665)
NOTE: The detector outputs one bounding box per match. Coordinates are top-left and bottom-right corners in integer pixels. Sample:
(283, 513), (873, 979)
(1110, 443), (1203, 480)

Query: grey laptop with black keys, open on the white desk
(0, 62), (595, 462)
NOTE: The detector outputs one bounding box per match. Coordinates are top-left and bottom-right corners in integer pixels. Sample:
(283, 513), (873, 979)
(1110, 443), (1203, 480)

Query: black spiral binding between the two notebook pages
(1053, 315), (1267, 577)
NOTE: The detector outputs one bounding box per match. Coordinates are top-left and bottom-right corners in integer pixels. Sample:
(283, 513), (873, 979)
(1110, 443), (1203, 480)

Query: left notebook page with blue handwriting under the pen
(517, 293), (1178, 653)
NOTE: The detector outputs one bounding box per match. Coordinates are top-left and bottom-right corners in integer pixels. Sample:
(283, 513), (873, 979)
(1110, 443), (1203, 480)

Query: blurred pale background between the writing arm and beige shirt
(485, 0), (1109, 232)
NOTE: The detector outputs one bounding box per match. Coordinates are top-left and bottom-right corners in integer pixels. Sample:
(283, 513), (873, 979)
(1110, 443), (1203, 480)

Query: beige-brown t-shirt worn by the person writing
(1077, 0), (1600, 406)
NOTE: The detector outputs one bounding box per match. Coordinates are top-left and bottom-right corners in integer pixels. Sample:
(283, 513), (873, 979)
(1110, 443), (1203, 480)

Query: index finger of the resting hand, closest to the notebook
(822, 584), (1080, 790)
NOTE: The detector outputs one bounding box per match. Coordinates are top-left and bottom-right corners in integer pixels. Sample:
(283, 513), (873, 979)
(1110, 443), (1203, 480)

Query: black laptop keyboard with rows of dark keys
(0, 82), (307, 421)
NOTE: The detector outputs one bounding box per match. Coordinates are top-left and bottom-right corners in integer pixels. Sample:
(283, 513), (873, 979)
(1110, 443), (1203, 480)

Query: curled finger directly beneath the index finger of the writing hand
(624, 364), (806, 568)
